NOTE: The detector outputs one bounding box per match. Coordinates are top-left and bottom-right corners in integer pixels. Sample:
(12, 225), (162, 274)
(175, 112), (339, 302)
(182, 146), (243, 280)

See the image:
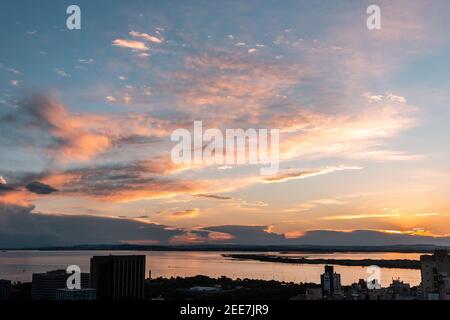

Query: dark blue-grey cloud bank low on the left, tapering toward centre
(0, 204), (184, 248)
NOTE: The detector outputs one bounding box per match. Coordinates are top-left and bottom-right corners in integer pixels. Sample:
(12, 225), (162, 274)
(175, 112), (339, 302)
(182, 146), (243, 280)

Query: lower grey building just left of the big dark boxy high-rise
(31, 270), (89, 300)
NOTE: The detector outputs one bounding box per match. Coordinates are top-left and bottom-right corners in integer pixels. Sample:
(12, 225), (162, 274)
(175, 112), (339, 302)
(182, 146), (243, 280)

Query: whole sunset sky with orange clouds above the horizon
(0, 0), (450, 245)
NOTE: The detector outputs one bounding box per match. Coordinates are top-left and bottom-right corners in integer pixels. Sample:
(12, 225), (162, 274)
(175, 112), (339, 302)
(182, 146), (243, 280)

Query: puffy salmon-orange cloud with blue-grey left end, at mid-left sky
(7, 95), (181, 162)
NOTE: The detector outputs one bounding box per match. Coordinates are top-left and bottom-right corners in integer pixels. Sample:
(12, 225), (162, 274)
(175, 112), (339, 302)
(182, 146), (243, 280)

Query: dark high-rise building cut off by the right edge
(420, 250), (450, 300)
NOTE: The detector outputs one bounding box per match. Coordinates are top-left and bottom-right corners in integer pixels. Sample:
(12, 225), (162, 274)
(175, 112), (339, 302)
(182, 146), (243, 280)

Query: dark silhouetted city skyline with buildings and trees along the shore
(0, 249), (450, 301)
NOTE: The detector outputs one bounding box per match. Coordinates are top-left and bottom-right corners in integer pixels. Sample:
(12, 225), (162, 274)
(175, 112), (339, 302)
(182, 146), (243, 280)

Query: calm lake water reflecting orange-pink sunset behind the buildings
(0, 251), (420, 286)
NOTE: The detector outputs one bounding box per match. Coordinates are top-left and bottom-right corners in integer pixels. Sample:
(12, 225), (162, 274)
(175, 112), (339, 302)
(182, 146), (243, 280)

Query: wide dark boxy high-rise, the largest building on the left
(91, 255), (145, 300)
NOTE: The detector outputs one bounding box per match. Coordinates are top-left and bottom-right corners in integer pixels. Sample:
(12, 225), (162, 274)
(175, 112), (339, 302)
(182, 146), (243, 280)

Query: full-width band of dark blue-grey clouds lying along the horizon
(0, 203), (450, 248)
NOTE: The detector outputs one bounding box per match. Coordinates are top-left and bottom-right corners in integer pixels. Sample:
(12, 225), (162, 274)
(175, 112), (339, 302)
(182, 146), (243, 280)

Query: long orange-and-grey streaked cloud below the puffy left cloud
(34, 157), (207, 202)
